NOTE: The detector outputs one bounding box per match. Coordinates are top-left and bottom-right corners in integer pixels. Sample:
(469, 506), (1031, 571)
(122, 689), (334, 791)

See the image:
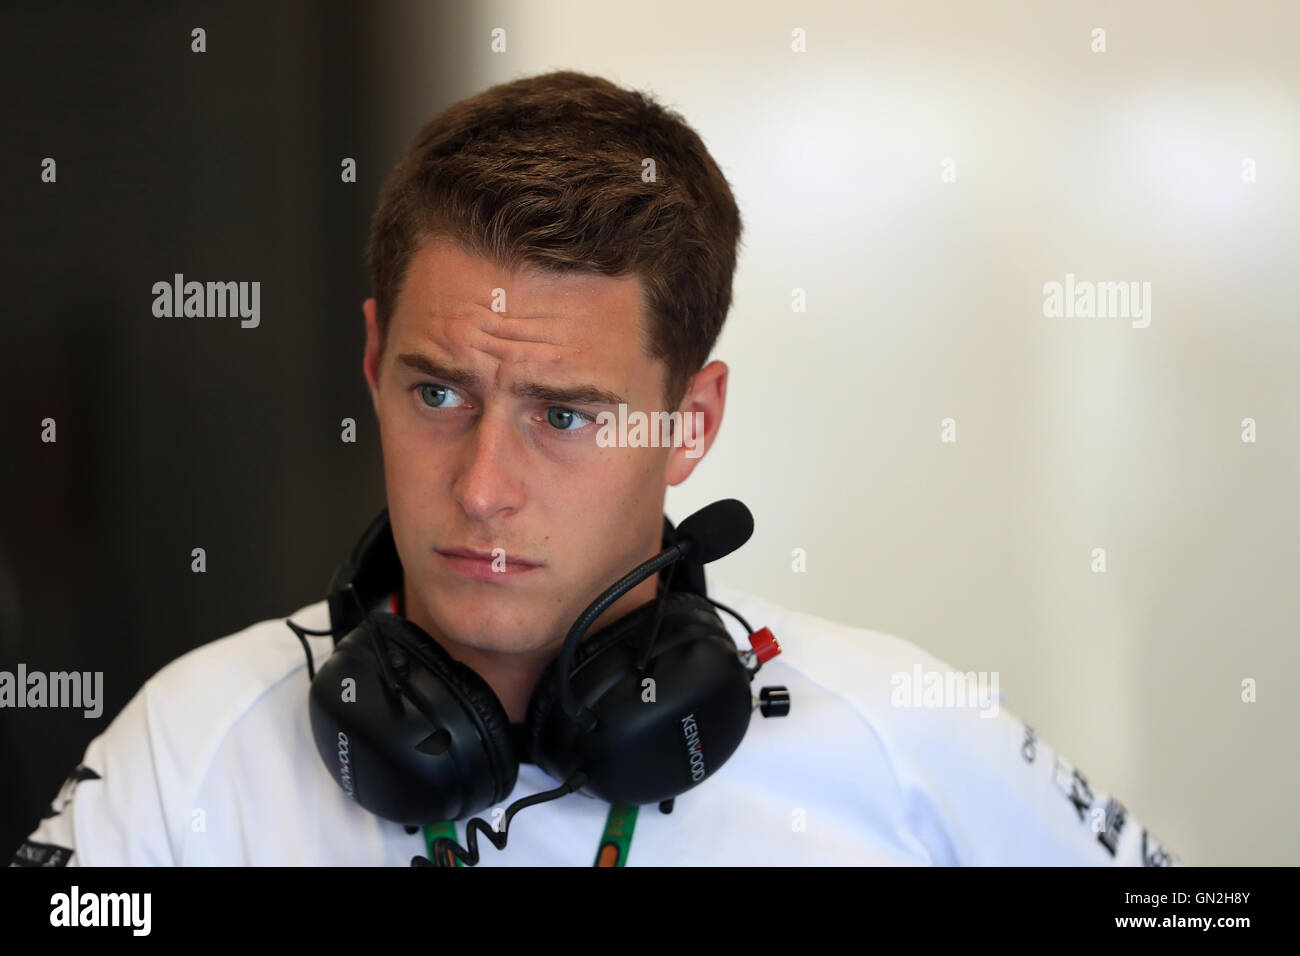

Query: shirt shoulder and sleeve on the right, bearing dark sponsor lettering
(710, 574), (1178, 866)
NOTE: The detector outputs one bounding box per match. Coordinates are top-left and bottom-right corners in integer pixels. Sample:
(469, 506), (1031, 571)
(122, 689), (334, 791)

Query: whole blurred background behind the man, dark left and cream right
(0, 0), (1300, 865)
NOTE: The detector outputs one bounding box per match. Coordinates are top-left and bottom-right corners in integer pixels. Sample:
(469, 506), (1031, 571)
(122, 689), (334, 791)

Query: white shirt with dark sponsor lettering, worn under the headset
(16, 585), (1178, 866)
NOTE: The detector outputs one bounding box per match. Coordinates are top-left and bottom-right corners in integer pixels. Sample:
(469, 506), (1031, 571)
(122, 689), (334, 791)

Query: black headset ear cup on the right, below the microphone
(528, 592), (753, 805)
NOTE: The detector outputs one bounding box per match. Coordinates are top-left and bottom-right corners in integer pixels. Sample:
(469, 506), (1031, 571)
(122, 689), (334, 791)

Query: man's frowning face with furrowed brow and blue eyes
(364, 239), (725, 653)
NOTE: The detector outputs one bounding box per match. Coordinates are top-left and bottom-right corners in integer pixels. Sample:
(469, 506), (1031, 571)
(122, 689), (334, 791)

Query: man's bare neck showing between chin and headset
(399, 575), (662, 723)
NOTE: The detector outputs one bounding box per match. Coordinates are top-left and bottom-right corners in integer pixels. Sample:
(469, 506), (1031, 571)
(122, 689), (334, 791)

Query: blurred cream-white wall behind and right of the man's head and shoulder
(372, 0), (1300, 864)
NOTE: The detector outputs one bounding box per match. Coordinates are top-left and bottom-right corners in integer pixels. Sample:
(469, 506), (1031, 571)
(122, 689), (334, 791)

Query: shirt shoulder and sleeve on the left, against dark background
(13, 601), (332, 866)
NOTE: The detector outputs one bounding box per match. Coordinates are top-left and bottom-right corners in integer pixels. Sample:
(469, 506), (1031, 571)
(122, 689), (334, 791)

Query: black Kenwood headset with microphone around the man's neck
(290, 499), (789, 858)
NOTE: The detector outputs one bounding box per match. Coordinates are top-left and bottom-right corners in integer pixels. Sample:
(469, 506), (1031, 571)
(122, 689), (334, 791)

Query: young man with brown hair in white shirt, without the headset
(16, 72), (1171, 866)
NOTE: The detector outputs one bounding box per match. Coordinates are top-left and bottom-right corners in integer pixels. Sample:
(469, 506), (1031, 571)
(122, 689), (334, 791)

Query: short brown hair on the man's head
(367, 70), (741, 410)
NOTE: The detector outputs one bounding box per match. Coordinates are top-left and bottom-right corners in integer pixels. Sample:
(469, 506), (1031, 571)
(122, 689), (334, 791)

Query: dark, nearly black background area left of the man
(0, 3), (400, 858)
